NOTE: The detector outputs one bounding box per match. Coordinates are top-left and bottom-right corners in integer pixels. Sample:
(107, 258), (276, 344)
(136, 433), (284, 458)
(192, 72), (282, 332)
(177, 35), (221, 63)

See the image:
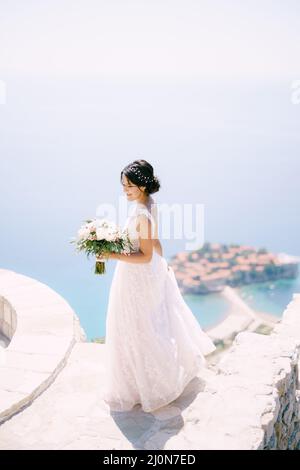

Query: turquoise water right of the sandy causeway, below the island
(236, 276), (300, 317)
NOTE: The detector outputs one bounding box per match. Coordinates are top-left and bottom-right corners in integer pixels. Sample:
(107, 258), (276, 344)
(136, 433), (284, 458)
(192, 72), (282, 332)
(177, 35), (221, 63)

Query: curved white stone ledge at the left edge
(0, 269), (86, 424)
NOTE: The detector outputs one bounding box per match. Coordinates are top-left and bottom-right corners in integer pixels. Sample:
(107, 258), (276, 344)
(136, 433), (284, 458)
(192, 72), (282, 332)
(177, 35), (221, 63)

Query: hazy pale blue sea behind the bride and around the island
(0, 77), (300, 339)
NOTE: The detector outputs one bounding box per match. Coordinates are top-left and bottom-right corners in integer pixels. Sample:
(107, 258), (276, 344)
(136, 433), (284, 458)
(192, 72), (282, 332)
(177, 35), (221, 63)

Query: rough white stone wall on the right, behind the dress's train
(210, 294), (300, 450)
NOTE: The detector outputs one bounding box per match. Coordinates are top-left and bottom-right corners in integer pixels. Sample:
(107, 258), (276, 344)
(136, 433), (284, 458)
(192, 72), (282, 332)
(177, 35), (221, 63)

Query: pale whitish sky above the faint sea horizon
(0, 0), (300, 80)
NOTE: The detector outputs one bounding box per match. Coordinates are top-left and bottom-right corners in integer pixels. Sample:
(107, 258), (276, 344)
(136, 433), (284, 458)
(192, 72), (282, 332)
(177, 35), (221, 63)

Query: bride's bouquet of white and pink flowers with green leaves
(70, 219), (132, 274)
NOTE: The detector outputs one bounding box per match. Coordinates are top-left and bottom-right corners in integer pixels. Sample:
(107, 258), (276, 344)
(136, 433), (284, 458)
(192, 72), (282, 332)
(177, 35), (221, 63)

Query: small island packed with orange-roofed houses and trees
(169, 242), (300, 294)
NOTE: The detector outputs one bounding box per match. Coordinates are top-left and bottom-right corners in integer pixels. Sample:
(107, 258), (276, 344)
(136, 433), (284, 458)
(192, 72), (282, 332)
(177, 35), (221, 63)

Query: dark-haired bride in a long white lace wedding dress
(96, 160), (216, 412)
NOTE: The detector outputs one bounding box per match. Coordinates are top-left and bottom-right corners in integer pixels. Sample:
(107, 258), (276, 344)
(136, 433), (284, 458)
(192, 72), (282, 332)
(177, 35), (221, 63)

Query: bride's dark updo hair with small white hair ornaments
(121, 160), (160, 195)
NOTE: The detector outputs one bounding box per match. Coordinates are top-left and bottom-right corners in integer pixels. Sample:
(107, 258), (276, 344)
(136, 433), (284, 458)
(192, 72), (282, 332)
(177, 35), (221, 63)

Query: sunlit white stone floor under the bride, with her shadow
(0, 343), (215, 450)
